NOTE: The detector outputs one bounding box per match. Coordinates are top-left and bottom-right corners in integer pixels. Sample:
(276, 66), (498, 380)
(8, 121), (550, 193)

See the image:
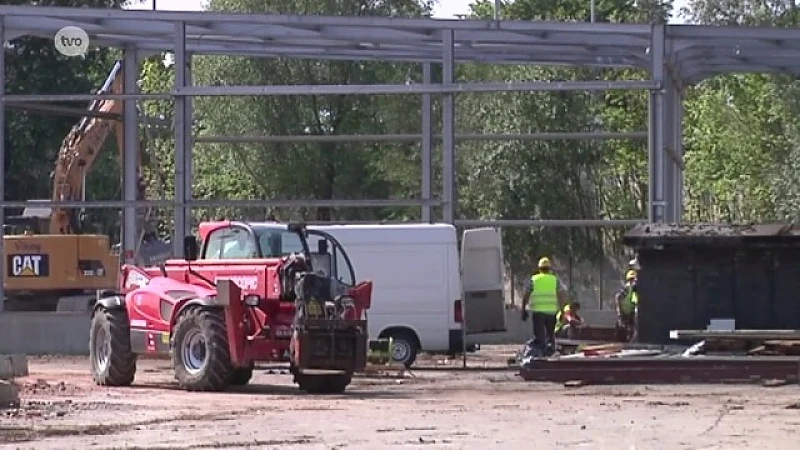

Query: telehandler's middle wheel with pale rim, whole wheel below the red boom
(172, 308), (234, 391)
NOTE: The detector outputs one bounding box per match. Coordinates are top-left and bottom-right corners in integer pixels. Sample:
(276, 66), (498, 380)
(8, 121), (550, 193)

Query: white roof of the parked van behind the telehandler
(308, 223), (457, 244)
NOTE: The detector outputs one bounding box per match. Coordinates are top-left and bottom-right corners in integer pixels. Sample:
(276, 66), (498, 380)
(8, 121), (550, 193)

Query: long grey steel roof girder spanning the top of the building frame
(0, 6), (800, 80)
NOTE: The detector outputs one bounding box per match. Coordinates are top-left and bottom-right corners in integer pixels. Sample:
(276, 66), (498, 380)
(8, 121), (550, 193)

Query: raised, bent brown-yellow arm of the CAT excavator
(50, 61), (144, 234)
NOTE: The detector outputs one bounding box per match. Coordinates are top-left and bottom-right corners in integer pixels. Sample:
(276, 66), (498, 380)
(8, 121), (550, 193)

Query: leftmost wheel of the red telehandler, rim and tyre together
(89, 308), (136, 386)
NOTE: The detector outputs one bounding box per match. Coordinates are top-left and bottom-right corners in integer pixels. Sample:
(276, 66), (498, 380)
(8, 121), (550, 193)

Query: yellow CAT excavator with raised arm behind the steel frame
(3, 61), (171, 311)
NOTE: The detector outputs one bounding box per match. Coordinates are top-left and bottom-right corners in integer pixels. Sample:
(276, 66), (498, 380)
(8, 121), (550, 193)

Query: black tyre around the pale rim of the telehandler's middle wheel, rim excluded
(172, 308), (234, 392)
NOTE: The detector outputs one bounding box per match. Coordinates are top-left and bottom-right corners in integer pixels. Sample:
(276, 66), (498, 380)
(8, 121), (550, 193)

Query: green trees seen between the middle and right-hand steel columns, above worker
(459, 0), (671, 292)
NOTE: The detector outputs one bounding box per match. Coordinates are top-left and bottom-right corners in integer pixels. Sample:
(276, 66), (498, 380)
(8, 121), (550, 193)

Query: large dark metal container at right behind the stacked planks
(623, 223), (800, 343)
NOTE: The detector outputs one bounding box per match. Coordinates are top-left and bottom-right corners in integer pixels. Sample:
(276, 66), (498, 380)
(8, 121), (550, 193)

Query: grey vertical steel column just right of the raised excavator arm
(122, 48), (139, 264)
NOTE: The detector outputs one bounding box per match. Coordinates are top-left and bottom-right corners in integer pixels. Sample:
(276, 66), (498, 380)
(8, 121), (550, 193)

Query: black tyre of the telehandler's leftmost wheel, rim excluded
(90, 308), (137, 386)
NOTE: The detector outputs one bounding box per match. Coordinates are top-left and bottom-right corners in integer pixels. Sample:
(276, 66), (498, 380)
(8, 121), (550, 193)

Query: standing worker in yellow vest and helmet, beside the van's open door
(522, 257), (566, 356)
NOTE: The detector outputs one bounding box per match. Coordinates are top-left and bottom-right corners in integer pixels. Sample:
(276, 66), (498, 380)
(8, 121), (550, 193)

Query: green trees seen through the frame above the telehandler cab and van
(185, 0), (430, 220)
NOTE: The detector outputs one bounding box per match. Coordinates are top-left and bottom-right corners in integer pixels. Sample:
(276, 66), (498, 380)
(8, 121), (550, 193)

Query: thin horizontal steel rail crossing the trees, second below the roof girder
(194, 131), (647, 143)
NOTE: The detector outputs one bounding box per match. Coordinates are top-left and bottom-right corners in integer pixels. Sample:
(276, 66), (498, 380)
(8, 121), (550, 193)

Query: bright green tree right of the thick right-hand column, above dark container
(683, 0), (800, 222)
